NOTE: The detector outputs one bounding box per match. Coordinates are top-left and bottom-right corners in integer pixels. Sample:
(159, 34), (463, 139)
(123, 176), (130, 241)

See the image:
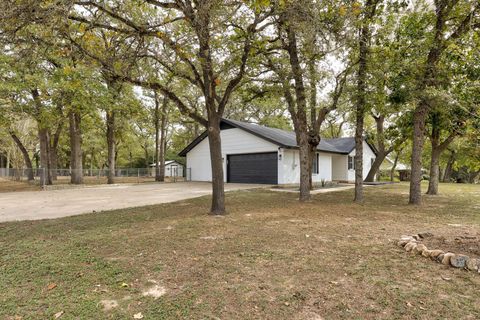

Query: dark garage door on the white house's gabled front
(227, 152), (278, 184)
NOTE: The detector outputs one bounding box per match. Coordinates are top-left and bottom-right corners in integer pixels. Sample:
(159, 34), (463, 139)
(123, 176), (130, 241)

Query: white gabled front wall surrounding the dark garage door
(187, 128), (280, 182)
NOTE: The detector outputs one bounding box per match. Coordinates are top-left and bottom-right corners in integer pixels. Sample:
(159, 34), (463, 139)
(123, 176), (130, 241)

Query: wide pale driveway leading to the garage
(0, 182), (262, 222)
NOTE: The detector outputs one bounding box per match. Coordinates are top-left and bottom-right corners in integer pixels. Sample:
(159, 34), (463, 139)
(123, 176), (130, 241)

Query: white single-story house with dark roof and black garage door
(179, 119), (375, 185)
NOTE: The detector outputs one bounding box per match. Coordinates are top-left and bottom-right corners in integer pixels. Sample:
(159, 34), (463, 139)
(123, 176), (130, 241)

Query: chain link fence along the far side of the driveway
(0, 167), (191, 186)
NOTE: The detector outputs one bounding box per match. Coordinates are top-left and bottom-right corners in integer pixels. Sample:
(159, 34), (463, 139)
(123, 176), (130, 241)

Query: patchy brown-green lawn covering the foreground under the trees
(0, 184), (480, 319)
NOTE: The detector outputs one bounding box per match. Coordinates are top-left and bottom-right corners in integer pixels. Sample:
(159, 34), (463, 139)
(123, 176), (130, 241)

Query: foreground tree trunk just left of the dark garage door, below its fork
(208, 114), (225, 215)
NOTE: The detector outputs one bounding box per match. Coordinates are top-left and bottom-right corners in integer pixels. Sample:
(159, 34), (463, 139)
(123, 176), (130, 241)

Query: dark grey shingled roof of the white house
(179, 119), (376, 156)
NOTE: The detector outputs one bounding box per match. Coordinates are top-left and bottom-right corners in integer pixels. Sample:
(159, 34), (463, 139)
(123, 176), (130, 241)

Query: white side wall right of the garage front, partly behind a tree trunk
(278, 149), (332, 184)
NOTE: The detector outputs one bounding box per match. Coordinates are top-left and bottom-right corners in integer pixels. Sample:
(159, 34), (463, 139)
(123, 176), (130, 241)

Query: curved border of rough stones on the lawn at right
(397, 232), (480, 274)
